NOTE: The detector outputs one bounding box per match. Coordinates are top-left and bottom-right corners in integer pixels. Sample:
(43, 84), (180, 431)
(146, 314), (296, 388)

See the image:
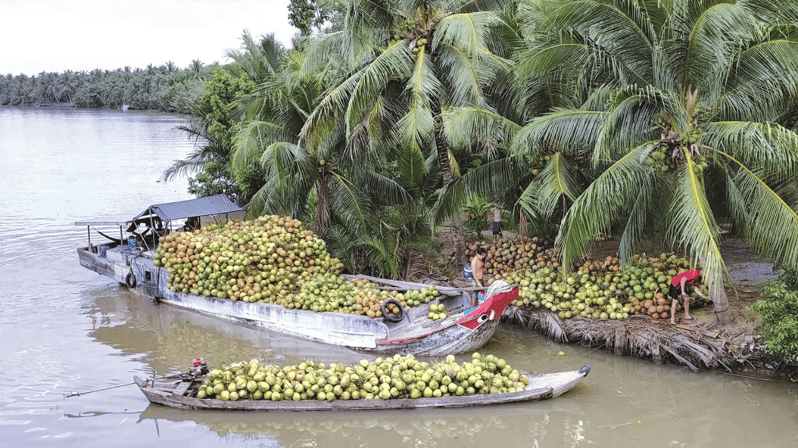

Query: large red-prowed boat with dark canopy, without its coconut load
(75, 195), (518, 356)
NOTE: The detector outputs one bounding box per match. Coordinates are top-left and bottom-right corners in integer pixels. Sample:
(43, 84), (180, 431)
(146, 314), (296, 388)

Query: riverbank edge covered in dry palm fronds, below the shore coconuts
(412, 231), (798, 381)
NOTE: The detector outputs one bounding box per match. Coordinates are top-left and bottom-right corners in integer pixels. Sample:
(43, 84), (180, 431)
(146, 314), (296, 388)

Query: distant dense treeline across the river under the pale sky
(0, 60), (213, 113)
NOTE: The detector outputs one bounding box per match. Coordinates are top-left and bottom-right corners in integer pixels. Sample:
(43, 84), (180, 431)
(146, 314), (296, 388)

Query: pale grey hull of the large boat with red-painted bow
(78, 246), (518, 356)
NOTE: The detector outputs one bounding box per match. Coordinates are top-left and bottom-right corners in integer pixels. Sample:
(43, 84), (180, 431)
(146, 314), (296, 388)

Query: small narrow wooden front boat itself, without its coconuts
(133, 364), (590, 411)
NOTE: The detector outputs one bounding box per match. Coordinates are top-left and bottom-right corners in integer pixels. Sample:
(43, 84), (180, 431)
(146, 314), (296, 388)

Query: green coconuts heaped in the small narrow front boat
(197, 352), (529, 401)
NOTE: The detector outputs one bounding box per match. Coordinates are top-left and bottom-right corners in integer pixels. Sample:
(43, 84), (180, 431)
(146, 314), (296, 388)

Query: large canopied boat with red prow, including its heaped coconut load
(76, 195), (518, 355)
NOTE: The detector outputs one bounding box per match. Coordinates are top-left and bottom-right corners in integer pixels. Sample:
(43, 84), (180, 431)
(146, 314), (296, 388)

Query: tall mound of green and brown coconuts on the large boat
(153, 215), (439, 318)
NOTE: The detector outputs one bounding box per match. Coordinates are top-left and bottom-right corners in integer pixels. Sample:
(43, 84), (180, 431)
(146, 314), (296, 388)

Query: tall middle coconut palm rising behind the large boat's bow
(300, 0), (509, 262)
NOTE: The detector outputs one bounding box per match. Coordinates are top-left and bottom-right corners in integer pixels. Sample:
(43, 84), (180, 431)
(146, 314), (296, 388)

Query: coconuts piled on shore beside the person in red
(468, 238), (708, 320)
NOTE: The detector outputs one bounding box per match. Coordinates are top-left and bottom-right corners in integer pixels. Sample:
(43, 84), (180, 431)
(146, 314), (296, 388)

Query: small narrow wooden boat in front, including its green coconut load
(135, 352), (590, 410)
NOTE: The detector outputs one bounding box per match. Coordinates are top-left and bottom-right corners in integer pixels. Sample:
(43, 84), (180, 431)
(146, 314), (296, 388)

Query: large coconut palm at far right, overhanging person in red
(512, 0), (798, 324)
